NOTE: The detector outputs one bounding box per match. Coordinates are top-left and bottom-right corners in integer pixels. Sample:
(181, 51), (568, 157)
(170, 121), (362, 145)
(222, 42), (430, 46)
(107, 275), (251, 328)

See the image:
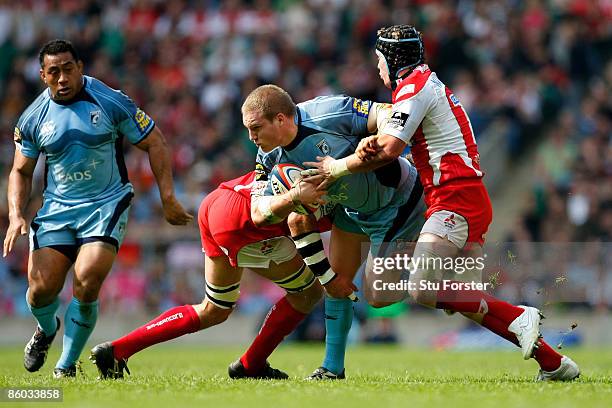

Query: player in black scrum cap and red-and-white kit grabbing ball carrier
(310, 25), (580, 381)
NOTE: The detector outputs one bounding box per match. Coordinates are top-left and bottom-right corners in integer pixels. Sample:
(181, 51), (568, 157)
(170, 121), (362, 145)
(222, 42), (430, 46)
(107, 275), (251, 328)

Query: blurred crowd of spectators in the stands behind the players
(0, 0), (612, 328)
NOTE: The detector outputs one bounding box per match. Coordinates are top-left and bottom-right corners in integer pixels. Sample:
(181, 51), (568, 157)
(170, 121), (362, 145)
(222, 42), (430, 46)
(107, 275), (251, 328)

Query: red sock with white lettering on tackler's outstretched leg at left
(112, 305), (200, 359)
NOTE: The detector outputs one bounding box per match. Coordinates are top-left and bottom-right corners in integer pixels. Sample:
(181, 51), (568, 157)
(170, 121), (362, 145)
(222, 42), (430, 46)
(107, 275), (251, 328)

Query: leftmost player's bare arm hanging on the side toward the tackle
(136, 126), (193, 225)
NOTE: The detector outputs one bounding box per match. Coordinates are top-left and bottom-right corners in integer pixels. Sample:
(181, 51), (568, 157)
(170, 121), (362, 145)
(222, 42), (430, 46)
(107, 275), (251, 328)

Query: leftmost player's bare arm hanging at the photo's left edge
(2, 149), (36, 257)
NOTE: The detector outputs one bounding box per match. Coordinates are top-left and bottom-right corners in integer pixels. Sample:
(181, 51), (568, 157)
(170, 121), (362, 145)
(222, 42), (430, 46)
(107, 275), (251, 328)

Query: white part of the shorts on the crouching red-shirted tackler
(238, 237), (297, 268)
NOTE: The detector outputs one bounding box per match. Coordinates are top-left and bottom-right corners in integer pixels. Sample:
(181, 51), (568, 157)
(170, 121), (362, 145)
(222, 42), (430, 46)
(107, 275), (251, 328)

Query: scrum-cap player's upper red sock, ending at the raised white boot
(436, 278), (524, 327)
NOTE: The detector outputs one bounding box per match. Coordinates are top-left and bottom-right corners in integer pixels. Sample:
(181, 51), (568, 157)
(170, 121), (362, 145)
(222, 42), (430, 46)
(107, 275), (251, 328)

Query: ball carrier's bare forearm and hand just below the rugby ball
(251, 177), (327, 227)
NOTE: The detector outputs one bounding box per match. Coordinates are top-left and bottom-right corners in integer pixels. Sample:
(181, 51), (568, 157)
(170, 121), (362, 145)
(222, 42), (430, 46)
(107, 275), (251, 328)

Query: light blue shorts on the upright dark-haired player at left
(30, 191), (134, 251)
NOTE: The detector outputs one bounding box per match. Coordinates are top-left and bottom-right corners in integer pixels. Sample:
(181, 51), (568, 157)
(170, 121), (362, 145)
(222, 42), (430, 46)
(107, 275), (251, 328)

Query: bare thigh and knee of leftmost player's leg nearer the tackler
(73, 241), (117, 302)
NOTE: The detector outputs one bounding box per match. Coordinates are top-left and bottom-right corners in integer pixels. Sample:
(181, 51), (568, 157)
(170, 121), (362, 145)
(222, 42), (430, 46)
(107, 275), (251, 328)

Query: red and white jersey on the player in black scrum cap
(379, 64), (483, 193)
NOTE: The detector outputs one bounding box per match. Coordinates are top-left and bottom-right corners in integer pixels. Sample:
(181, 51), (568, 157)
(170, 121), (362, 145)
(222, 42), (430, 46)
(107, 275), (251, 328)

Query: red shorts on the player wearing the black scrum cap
(425, 180), (493, 245)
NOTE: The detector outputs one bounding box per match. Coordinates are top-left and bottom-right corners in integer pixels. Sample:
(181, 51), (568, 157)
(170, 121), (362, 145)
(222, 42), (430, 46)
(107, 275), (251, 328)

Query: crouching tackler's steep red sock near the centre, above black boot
(240, 297), (306, 374)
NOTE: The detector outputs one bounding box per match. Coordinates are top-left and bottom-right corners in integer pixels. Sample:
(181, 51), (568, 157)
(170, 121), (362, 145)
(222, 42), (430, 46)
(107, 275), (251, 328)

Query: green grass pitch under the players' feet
(0, 345), (612, 408)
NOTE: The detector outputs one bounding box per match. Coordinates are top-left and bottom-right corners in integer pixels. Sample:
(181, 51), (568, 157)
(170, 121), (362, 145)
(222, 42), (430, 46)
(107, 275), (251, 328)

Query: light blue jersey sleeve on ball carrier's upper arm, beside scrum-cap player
(298, 95), (372, 137)
